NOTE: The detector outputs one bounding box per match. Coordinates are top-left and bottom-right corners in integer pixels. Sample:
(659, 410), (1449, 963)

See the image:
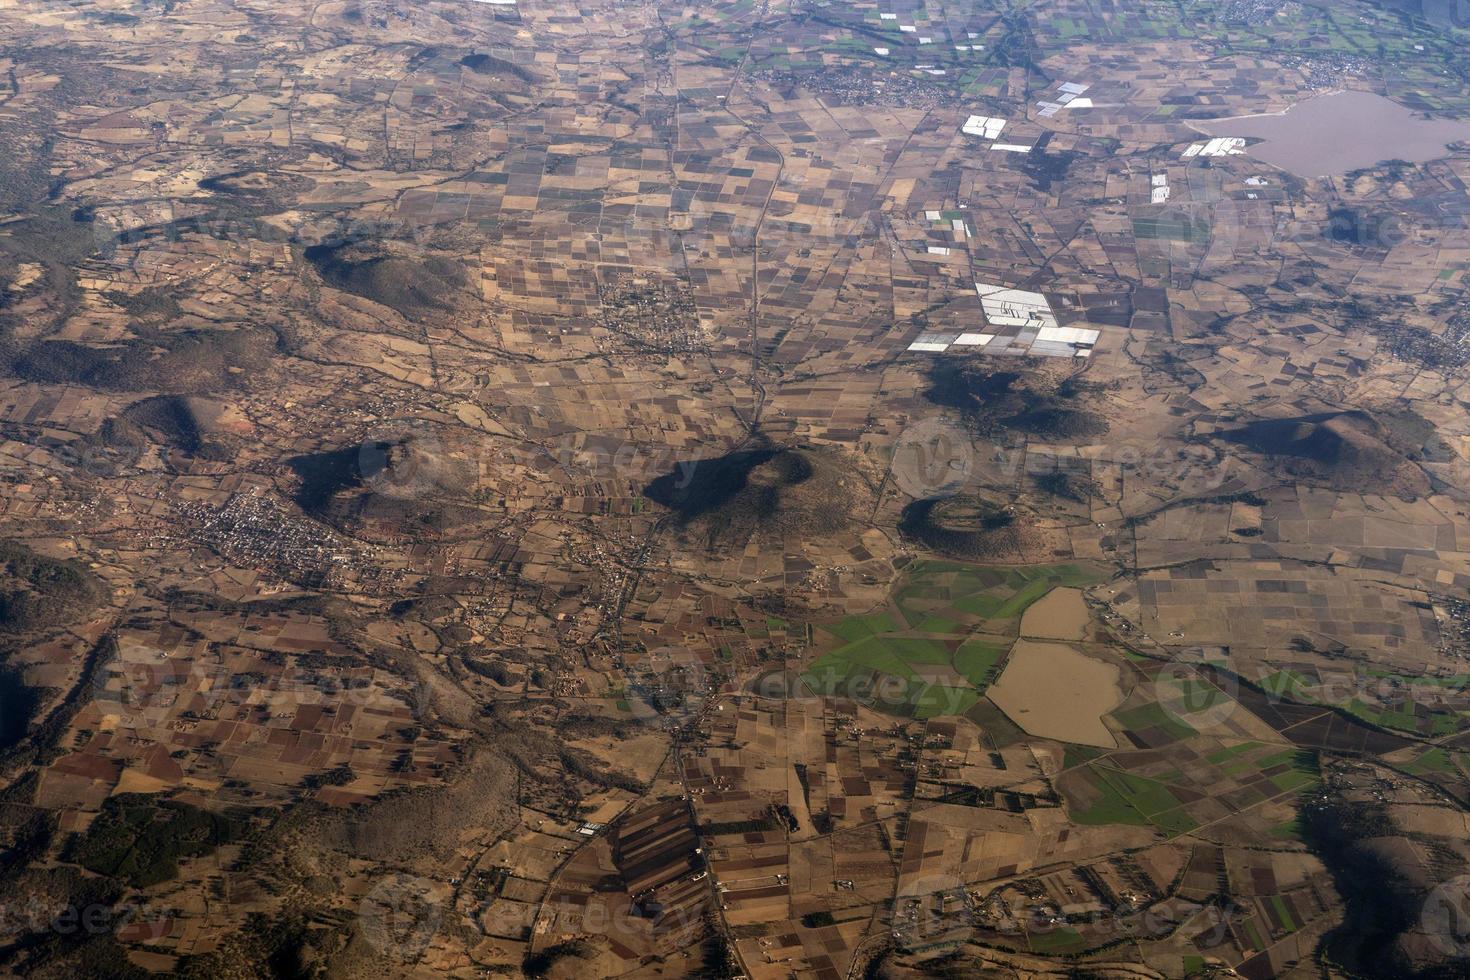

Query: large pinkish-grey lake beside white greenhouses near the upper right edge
(1192, 93), (1470, 176)
